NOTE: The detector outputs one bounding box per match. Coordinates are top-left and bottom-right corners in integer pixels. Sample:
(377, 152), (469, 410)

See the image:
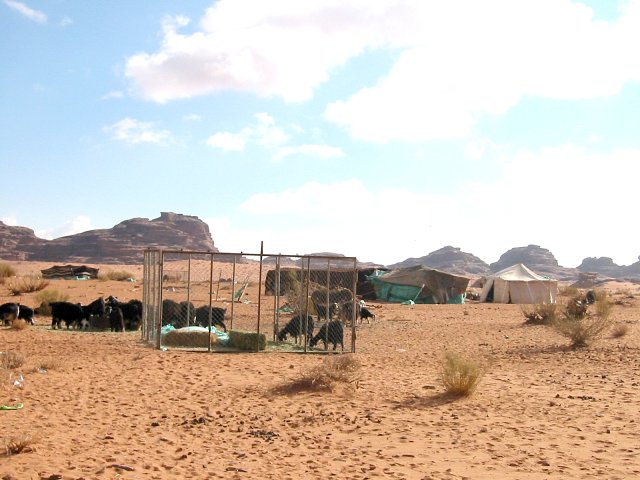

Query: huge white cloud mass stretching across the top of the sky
(126, 0), (640, 142)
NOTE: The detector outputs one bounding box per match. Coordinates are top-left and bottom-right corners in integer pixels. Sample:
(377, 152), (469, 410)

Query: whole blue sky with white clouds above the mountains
(0, 0), (640, 267)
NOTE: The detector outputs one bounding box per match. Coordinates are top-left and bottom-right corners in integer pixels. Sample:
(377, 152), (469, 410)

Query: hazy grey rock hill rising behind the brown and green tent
(389, 245), (491, 276)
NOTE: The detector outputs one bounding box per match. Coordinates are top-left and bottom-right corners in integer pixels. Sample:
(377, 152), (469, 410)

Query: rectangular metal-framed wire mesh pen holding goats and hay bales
(142, 249), (358, 353)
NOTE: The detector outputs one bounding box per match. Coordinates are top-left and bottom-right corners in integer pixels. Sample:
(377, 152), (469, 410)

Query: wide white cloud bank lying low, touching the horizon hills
(225, 145), (640, 267)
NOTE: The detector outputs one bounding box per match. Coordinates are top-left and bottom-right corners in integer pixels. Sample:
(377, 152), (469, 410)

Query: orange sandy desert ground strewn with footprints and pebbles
(0, 262), (640, 480)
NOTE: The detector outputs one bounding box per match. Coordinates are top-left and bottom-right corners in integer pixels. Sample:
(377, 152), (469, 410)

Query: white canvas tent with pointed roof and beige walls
(480, 263), (558, 304)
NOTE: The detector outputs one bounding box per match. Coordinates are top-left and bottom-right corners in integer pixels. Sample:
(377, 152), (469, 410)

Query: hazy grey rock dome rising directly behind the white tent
(490, 245), (578, 280)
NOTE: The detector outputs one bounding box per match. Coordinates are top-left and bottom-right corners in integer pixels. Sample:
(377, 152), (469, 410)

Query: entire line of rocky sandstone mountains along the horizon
(0, 212), (640, 280)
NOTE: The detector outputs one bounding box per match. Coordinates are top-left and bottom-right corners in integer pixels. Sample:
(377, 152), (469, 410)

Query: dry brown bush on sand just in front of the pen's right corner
(274, 354), (362, 394)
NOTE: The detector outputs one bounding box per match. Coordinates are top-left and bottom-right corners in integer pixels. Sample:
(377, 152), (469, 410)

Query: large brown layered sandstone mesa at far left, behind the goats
(0, 212), (218, 263)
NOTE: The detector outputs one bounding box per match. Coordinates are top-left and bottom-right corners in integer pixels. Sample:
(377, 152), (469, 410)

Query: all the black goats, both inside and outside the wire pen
(0, 290), (375, 350)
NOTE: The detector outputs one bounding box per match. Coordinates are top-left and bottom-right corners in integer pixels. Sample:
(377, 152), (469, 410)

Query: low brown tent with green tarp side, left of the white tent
(370, 265), (470, 303)
